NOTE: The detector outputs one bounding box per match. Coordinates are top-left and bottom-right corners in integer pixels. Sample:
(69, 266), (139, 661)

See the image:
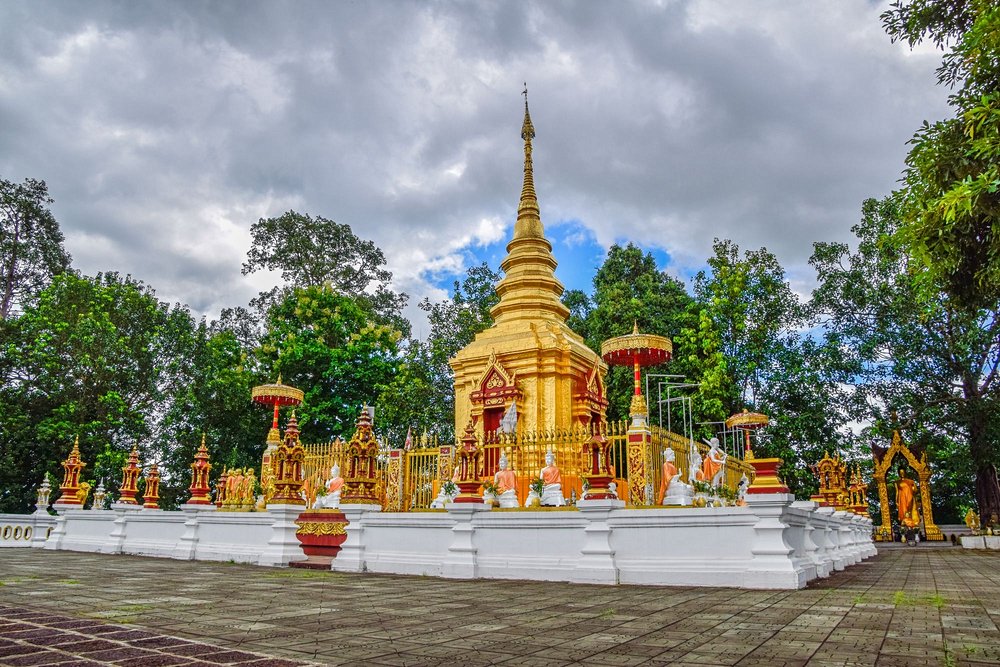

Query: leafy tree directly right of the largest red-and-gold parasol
(682, 239), (847, 496)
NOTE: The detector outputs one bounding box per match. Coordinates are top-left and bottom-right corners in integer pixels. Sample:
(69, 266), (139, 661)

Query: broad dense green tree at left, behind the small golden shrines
(0, 273), (190, 511)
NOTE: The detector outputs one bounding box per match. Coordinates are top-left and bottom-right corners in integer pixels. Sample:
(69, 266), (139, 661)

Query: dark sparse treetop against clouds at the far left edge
(0, 178), (70, 320)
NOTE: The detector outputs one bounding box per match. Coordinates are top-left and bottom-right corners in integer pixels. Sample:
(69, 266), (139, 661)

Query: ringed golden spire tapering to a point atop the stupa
(490, 84), (569, 324)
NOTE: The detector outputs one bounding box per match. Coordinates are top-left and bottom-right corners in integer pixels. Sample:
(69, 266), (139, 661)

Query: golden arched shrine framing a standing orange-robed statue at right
(872, 431), (944, 542)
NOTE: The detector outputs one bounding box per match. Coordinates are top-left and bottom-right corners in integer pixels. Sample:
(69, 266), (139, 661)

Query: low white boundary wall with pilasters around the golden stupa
(23, 494), (876, 589)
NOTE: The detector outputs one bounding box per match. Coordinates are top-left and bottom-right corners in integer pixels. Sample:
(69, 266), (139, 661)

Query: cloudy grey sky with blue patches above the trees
(0, 0), (948, 333)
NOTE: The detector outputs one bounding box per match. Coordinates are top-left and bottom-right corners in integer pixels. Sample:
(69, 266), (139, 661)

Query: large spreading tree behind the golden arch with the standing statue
(810, 198), (1000, 520)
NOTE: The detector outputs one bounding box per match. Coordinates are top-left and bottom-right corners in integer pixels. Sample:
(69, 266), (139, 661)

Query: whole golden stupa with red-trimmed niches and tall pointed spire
(450, 98), (607, 434)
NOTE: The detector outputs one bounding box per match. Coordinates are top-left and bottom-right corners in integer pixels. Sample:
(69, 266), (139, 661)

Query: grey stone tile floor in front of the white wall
(0, 547), (1000, 667)
